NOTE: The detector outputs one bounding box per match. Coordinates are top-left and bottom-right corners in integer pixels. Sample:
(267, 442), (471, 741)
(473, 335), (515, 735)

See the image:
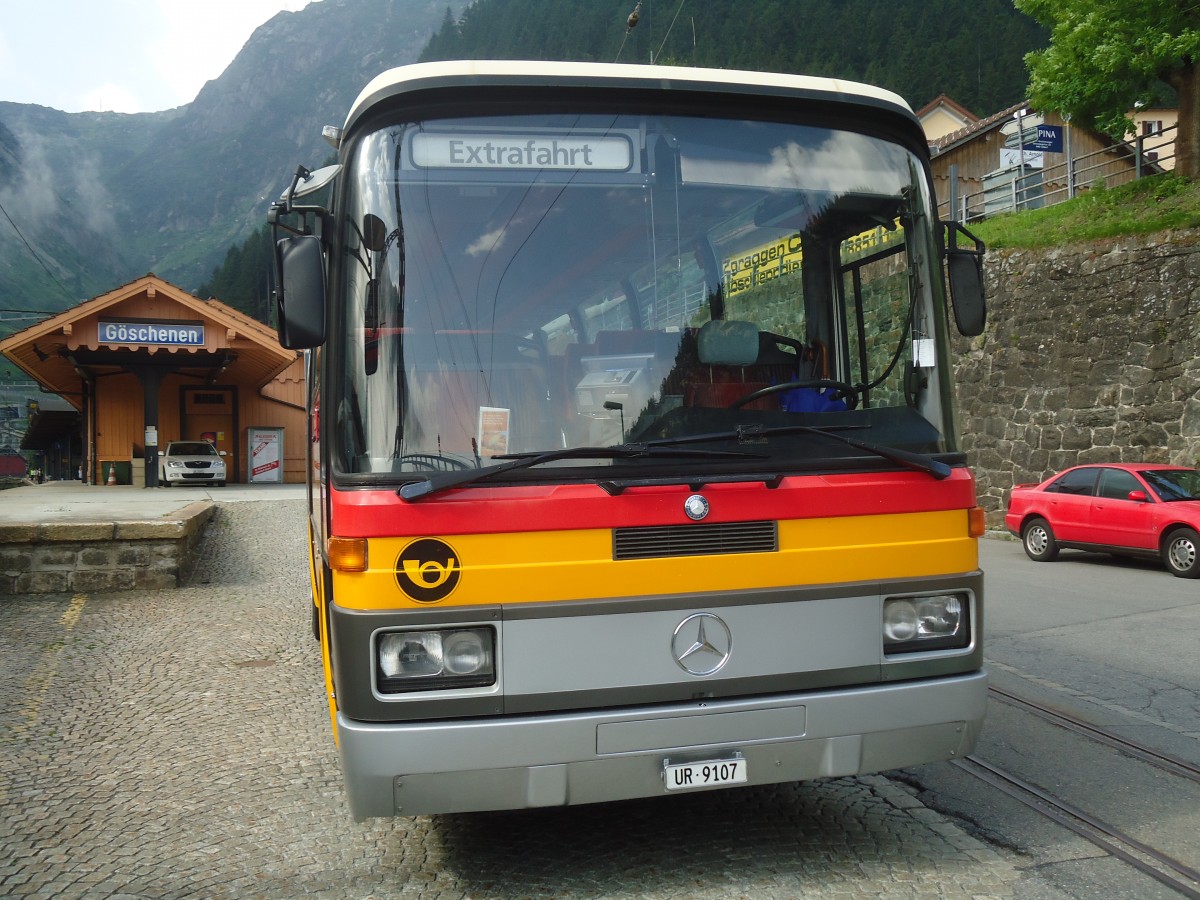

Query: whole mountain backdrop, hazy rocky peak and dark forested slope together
(0, 0), (1046, 328)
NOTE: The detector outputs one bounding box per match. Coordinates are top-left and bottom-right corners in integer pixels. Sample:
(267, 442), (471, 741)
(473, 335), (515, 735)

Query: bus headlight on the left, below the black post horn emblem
(376, 628), (496, 694)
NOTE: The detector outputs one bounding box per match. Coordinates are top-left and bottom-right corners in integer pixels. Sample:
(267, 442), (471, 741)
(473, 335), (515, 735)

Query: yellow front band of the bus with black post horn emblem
(336, 510), (978, 610)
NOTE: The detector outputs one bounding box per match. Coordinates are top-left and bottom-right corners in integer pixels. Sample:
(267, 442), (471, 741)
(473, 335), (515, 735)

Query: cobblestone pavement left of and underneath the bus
(0, 500), (1020, 899)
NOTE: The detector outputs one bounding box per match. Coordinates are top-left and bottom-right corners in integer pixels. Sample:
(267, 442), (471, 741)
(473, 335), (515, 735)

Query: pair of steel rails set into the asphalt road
(954, 688), (1200, 900)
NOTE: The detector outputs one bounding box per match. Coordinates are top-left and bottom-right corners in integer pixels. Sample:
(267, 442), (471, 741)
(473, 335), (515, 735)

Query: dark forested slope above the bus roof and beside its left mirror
(197, 0), (1048, 320)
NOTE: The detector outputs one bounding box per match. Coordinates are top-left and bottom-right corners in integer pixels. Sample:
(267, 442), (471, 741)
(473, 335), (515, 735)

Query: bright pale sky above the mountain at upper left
(0, 0), (310, 113)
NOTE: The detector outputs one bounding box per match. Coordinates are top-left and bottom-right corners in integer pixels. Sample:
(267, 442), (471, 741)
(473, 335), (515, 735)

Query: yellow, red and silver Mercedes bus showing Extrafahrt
(270, 61), (986, 818)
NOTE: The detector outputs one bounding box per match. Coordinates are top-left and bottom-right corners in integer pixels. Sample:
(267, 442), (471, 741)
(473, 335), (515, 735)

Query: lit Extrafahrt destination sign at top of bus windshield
(409, 131), (634, 172)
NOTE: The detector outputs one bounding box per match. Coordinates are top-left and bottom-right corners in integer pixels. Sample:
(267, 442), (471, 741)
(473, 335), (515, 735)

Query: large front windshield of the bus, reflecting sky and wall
(324, 112), (956, 482)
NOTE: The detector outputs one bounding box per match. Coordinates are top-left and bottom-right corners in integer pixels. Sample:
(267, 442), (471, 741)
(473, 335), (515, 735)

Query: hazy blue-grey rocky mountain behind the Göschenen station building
(0, 0), (462, 316)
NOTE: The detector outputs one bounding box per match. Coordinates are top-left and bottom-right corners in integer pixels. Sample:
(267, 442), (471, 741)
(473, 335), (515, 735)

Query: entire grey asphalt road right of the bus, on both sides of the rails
(901, 540), (1200, 900)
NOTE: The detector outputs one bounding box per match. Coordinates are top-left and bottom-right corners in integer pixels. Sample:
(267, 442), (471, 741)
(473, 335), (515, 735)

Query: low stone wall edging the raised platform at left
(0, 503), (215, 595)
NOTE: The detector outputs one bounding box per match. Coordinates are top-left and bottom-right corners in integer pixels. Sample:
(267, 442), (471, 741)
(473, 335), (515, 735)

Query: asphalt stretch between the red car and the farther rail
(982, 540), (1200, 763)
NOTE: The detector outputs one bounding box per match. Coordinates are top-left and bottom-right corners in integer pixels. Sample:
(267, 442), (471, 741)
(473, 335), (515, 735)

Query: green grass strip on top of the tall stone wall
(970, 174), (1200, 248)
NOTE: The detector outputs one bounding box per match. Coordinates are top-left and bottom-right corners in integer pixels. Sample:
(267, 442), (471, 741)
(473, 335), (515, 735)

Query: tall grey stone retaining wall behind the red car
(955, 230), (1200, 529)
